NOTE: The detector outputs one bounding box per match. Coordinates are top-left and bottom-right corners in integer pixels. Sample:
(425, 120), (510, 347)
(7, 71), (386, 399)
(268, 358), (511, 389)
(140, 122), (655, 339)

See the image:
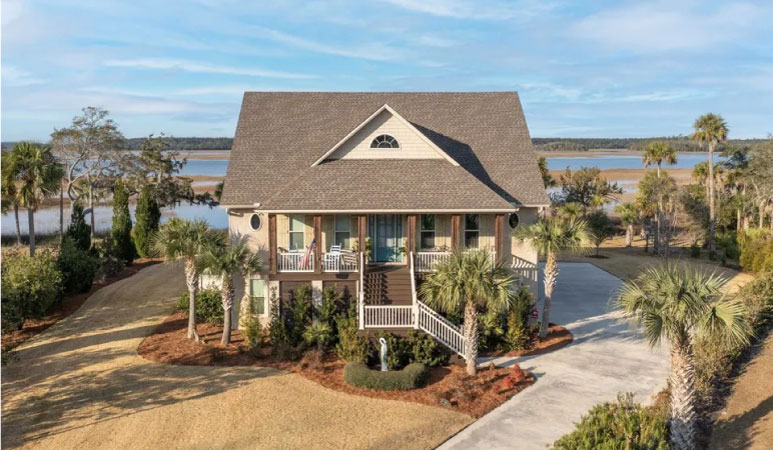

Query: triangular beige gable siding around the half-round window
(328, 111), (443, 159)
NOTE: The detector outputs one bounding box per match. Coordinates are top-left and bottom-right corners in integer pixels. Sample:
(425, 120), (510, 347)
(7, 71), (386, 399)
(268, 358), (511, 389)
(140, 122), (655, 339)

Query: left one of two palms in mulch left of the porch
(153, 217), (218, 342)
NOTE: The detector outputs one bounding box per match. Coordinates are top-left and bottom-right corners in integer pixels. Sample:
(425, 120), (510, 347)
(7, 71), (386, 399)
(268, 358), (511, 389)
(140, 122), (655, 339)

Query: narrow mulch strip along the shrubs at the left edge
(2, 258), (163, 350)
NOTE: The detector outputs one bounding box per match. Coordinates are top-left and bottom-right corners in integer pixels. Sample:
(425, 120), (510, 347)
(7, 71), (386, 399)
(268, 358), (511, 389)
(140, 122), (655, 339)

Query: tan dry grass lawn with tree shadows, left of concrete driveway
(2, 265), (472, 449)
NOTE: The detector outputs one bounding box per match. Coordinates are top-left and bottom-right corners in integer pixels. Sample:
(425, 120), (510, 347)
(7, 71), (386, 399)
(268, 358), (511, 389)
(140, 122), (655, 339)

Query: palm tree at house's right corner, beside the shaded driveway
(513, 217), (590, 339)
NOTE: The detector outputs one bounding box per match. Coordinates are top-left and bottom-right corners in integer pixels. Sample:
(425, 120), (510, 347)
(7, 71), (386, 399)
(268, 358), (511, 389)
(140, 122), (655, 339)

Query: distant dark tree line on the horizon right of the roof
(531, 136), (765, 152)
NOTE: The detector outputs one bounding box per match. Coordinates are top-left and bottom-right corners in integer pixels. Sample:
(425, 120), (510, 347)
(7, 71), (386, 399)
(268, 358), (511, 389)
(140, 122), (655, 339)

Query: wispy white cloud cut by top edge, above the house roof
(383, 0), (554, 20)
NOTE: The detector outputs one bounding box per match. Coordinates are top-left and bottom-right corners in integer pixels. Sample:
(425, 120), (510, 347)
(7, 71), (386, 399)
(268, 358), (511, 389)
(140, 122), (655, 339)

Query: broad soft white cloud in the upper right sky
(569, 1), (764, 53)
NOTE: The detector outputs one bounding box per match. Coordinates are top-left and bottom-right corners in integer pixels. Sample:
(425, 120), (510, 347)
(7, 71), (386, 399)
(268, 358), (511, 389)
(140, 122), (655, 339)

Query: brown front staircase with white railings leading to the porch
(360, 253), (465, 357)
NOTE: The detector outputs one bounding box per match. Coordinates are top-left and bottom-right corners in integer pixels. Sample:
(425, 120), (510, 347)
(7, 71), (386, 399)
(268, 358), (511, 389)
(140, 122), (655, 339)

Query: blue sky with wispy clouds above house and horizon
(1, 0), (773, 140)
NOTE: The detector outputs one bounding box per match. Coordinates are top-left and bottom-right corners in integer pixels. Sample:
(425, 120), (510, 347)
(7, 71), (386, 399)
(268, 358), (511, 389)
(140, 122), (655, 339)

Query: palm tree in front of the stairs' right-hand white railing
(419, 250), (515, 375)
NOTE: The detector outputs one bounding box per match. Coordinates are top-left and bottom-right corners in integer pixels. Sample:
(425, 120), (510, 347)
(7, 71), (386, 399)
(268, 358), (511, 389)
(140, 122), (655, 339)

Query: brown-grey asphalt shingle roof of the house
(221, 92), (548, 211)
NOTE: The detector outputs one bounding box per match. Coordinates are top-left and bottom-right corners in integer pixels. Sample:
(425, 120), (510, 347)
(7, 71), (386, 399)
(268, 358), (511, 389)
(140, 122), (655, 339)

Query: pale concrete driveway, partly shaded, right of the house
(440, 263), (668, 449)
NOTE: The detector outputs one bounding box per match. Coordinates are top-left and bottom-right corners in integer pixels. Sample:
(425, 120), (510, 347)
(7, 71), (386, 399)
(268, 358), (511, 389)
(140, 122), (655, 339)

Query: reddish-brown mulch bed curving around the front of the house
(137, 312), (572, 418)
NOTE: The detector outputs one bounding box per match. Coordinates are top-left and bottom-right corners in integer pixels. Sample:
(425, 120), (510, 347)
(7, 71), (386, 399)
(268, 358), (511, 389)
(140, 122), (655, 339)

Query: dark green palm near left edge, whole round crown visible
(11, 142), (64, 256)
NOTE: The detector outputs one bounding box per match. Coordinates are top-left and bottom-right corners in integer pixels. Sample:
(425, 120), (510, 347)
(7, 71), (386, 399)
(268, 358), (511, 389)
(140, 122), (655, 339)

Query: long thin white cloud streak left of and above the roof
(104, 58), (316, 80)
